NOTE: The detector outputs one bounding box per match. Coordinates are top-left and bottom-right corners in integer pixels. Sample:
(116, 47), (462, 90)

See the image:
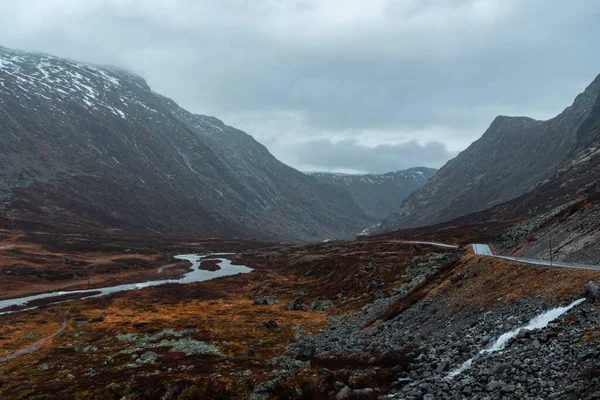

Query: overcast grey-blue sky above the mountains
(0, 0), (600, 172)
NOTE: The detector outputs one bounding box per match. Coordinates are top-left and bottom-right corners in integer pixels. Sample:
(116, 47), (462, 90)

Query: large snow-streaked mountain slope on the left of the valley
(0, 47), (374, 240)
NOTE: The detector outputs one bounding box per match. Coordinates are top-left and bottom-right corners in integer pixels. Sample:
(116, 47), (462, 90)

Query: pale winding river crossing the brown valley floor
(0, 253), (252, 315)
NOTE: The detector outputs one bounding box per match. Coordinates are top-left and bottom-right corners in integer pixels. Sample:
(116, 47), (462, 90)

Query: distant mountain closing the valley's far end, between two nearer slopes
(309, 167), (437, 220)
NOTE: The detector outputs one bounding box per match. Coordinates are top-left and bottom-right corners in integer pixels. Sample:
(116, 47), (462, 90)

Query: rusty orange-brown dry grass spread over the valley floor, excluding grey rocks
(0, 225), (600, 400)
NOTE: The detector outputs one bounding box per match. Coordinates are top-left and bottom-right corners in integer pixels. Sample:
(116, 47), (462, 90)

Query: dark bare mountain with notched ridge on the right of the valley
(381, 72), (600, 230)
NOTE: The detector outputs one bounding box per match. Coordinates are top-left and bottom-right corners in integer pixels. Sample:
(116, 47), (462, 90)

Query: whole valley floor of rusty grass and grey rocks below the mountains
(0, 227), (600, 400)
